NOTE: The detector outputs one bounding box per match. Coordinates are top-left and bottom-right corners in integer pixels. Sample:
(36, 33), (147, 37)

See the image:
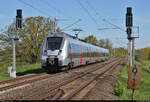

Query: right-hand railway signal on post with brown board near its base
(126, 7), (141, 100)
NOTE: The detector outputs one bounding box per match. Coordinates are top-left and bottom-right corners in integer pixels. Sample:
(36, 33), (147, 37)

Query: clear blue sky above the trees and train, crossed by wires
(0, 0), (150, 49)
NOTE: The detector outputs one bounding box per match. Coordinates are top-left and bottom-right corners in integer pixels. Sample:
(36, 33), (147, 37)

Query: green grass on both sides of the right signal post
(114, 61), (150, 100)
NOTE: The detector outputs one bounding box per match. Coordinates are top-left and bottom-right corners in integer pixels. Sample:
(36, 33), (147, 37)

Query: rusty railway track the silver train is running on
(0, 58), (115, 92)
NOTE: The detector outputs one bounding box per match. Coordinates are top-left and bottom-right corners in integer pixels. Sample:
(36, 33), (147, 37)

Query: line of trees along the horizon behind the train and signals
(0, 16), (150, 63)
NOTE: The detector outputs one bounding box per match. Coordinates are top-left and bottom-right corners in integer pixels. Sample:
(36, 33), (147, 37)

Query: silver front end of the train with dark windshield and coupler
(41, 34), (65, 72)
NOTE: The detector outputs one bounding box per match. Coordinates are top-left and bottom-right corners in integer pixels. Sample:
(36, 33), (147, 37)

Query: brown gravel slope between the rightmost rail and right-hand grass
(82, 65), (122, 100)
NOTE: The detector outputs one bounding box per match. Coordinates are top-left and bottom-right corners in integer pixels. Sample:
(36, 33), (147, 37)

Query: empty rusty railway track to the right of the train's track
(22, 59), (120, 100)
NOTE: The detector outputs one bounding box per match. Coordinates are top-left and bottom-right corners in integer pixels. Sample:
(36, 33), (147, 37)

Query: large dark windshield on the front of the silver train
(47, 37), (63, 50)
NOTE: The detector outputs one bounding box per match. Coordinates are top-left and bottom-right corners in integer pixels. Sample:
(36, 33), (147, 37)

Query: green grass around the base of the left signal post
(0, 56), (44, 81)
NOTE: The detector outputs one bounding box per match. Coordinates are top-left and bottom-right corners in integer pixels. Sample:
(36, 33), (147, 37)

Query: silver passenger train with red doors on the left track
(41, 32), (109, 72)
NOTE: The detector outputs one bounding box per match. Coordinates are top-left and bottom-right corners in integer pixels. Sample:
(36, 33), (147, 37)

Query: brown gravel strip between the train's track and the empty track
(0, 60), (106, 100)
